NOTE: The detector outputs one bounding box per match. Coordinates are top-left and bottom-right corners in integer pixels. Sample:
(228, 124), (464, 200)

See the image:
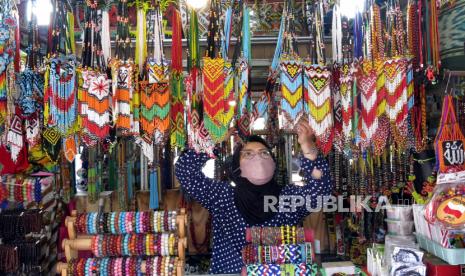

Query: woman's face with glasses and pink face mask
(240, 148), (276, 185)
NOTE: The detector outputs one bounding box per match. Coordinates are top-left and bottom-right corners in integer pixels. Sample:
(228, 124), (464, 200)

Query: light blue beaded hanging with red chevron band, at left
(44, 56), (77, 135)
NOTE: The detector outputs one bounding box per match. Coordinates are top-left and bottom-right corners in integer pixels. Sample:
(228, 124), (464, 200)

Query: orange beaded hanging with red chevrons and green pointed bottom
(202, 57), (228, 143)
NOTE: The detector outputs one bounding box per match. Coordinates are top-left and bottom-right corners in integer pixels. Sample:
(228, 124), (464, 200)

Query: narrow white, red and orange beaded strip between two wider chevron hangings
(339, 63), (354, 144)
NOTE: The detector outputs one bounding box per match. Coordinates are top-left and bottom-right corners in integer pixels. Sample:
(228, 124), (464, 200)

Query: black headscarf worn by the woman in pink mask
(227, 135), (281, 225)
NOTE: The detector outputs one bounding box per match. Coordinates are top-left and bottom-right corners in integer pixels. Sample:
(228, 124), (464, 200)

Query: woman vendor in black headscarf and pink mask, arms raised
(176, 122), (332, 274)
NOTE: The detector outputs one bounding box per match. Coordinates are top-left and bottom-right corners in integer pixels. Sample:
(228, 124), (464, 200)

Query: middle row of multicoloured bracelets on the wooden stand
(91, 233), (178, 257)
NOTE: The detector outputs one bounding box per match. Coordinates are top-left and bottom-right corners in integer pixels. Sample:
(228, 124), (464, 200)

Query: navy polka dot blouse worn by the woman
(175, 150), (332, 274)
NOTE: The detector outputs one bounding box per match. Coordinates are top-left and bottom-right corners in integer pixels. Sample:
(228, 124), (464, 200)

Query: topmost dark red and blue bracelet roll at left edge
(0, 177), (42, 203)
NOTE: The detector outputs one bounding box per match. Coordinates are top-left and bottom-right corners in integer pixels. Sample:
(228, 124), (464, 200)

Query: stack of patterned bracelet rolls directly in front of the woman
(242, 225), (318, 276)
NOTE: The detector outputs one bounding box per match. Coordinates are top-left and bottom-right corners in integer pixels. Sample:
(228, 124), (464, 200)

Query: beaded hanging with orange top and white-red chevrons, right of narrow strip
(357, 62), (378, 148)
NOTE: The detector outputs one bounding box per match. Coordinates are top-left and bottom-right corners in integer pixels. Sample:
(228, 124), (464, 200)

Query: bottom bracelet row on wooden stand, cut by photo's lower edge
(67, 257), (177, 276)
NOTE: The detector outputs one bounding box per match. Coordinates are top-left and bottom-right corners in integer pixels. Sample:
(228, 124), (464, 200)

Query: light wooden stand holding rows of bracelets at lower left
(56, 208), (187, 276)
